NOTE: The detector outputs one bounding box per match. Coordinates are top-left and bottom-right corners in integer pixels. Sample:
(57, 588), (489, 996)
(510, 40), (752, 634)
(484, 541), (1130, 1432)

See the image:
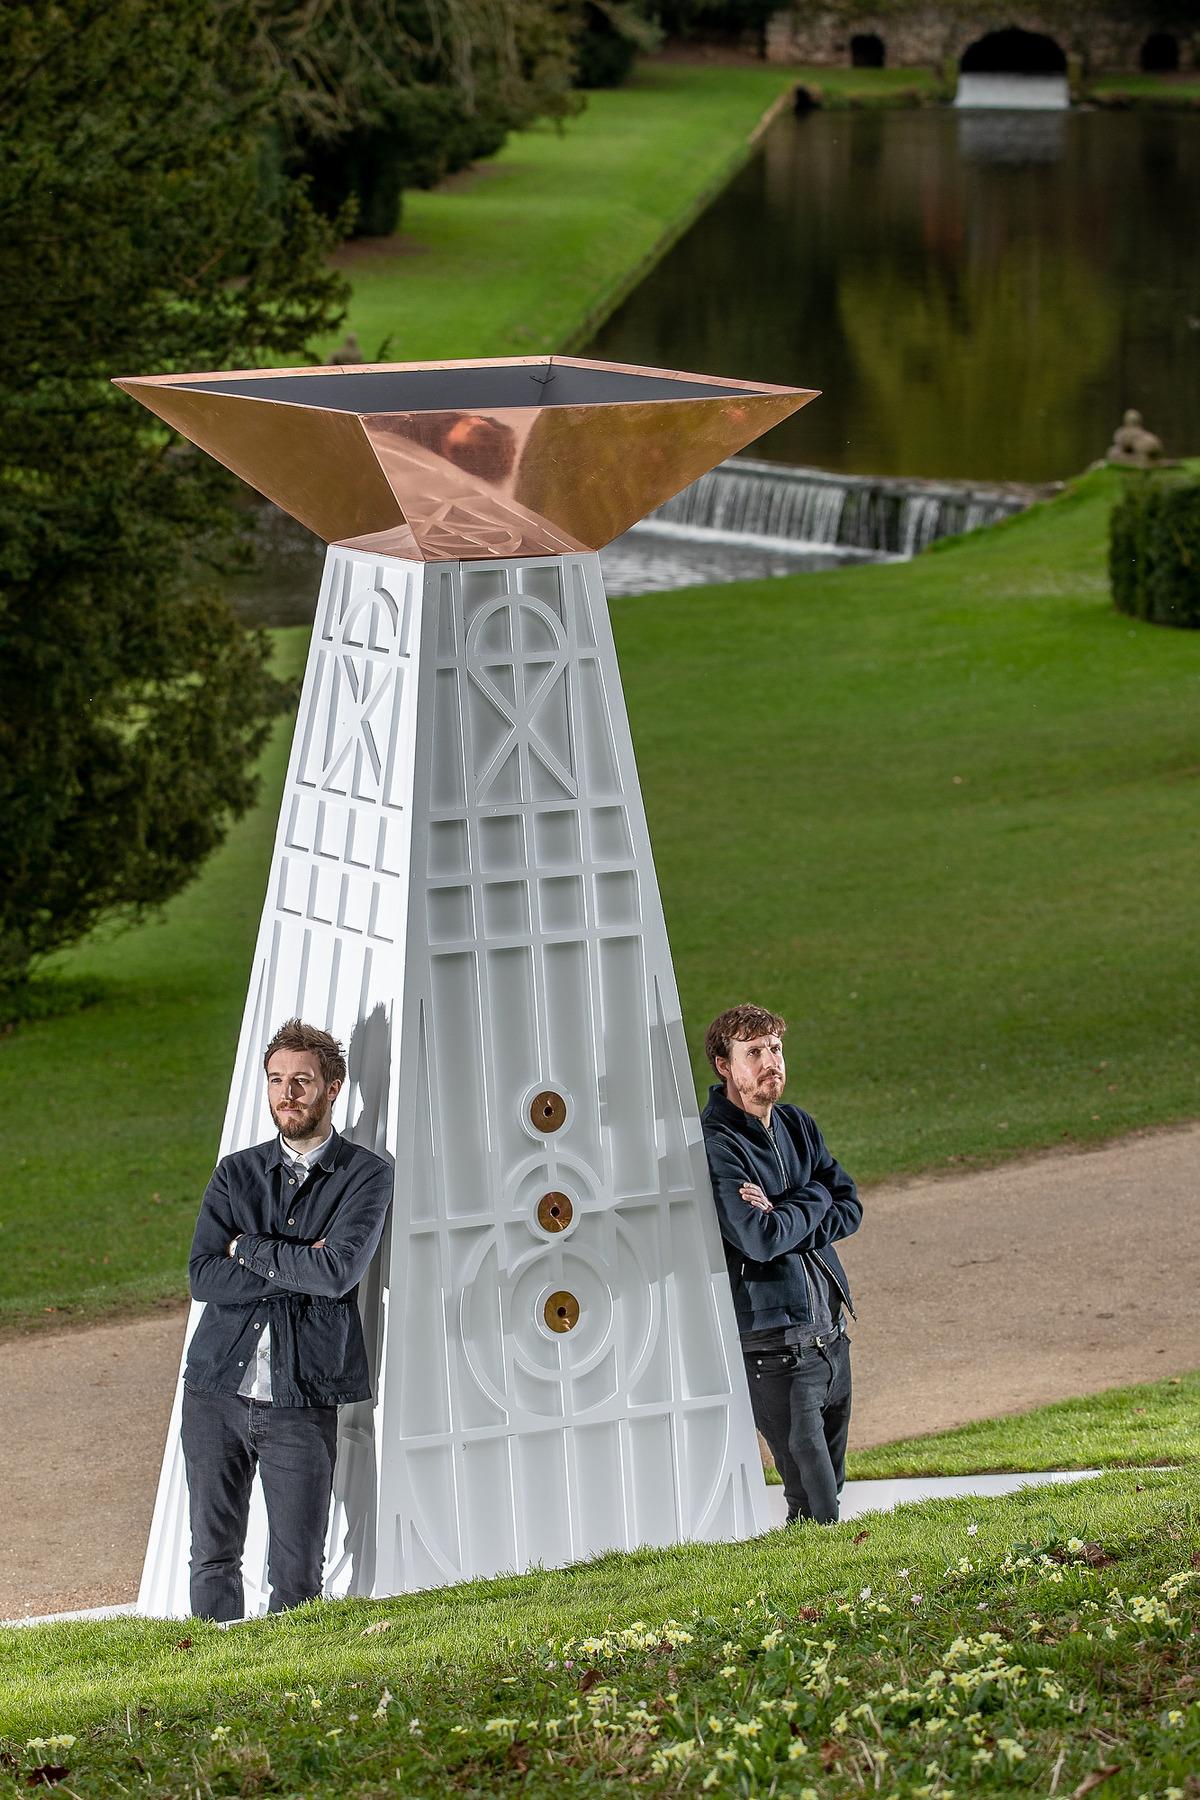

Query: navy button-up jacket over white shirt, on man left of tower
(184, 1132), (392, 1406)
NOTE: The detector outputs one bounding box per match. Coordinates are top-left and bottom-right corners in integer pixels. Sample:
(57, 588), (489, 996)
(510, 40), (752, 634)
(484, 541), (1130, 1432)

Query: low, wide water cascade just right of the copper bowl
(642, 457), (1033, 556)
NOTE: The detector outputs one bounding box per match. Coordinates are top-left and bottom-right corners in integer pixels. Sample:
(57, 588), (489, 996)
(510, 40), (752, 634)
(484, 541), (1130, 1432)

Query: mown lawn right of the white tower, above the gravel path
(636, 472), (1200, 1177)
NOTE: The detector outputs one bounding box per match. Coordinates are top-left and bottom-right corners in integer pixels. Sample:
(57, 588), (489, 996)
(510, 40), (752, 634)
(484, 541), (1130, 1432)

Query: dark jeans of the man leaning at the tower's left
(182, 1382), (338, 1620)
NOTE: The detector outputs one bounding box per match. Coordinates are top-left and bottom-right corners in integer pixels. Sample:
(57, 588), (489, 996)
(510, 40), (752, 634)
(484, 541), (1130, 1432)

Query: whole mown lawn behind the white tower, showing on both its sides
(0, 472), (1200, 1323)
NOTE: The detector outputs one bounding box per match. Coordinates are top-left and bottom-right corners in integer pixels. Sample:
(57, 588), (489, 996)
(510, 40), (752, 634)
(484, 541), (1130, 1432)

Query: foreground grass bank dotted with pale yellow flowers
(0, 1465), (1200, 1800)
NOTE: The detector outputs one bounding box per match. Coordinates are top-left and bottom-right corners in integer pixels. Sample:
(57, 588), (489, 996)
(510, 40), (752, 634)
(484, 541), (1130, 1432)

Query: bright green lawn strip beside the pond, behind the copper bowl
(324, 61), (795, 362)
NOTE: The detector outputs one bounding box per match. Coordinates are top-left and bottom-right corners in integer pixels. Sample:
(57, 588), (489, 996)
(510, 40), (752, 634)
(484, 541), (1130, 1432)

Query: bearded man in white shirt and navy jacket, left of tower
(184, 1019), (392, 1620)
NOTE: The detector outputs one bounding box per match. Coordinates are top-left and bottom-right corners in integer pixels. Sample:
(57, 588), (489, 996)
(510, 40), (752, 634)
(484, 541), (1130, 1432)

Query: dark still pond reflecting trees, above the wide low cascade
(588, 108), (1200, 481)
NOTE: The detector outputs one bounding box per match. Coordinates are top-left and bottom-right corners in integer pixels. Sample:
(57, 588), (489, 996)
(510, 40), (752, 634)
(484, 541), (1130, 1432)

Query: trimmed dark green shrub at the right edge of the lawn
(1108, 475), (1200, 630)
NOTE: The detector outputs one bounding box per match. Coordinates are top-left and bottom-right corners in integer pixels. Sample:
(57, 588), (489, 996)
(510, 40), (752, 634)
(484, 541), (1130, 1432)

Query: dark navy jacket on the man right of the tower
(700, 1084), (862, 1334)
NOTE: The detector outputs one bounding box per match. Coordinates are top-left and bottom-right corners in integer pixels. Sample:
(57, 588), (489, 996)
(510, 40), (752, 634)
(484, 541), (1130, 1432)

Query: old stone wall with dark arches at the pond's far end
(766, 0), (1200, 76)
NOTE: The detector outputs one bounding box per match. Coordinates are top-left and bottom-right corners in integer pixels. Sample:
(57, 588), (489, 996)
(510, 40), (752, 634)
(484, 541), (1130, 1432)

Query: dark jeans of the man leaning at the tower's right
(743, 1334), (851, 1525)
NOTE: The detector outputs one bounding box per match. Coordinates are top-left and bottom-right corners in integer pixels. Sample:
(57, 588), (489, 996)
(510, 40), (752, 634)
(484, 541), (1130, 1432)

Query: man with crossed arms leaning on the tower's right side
(702, 1006), (862, 1525)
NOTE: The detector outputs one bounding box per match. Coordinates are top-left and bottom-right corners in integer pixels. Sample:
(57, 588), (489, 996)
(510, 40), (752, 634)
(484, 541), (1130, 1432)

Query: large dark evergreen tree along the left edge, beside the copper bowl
(0, 0), (342, 1017)
